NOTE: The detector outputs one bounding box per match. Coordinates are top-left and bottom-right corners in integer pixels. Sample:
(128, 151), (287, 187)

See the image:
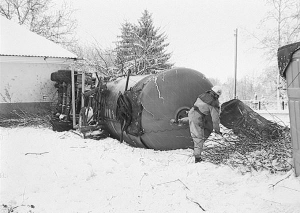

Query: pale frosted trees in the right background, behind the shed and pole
(218, 0), (300, 105)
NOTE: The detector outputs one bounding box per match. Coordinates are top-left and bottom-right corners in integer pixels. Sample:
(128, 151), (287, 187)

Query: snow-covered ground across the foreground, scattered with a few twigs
(0, 127), (300, 213)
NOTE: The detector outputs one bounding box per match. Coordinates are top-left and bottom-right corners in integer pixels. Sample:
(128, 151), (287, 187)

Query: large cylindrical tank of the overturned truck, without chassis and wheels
(105, 68), (212, 150)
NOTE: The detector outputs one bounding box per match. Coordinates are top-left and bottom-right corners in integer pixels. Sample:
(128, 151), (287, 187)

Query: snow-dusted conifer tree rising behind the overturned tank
(116, 10), (172, 74)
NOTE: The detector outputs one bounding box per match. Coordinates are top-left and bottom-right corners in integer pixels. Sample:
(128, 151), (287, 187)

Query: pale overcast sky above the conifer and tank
(67, 0), (267, 81)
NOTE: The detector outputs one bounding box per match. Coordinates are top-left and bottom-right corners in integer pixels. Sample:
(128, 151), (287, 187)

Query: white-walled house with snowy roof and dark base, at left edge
(0, 16), (77, 118)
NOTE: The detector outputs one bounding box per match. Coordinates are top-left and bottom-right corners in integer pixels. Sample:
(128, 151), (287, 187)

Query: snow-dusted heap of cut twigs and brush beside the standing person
(203, 127), (292, 173)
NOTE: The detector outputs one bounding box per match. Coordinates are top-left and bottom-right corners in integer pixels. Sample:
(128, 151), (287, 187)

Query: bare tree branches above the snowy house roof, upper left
(0, 0), (77, 46)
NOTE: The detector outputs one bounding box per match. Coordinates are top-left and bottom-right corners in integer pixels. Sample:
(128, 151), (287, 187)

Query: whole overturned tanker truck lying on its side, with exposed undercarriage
(51, 68), (213, 150)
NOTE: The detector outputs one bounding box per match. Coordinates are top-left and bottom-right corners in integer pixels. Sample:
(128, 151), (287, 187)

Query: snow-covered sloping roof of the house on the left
(0, 15), (77, 59)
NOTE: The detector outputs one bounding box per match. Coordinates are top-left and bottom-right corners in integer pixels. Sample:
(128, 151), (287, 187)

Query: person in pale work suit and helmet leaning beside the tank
(171, 86), (222, 163)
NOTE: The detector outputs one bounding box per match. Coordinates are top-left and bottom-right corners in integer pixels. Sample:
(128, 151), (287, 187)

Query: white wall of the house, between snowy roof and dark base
(0, 56), (73, 103)
